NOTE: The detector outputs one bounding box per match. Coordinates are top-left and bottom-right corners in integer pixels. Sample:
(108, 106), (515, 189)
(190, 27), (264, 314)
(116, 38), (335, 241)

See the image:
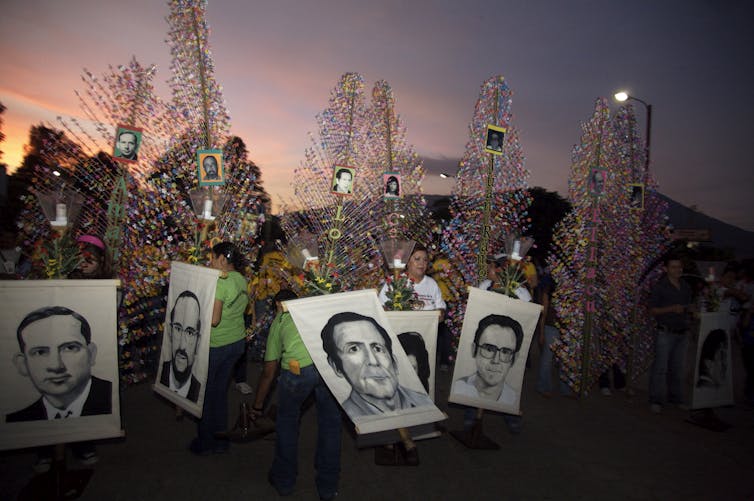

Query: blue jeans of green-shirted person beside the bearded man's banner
(197, 339), (246, 452)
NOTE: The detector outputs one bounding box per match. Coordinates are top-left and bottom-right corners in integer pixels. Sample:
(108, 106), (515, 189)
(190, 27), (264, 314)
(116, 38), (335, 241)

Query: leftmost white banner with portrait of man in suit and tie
(0, 280), (123, 450)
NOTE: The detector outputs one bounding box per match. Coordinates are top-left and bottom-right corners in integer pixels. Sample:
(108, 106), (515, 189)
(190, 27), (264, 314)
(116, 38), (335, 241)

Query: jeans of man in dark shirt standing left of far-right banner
(649, 330), (689, 404)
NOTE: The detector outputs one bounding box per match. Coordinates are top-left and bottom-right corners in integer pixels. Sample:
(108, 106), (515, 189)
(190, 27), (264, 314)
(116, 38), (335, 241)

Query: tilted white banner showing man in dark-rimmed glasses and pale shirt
(448, 287), (542, 414)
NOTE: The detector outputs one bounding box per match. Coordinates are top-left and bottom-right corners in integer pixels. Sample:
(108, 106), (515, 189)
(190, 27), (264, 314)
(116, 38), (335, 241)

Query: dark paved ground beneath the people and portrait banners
(0, 344), (754, 501)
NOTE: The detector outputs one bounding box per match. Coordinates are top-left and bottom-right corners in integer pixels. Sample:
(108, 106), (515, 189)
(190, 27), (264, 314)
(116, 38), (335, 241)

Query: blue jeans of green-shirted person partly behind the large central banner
(270, 365), (341, 498)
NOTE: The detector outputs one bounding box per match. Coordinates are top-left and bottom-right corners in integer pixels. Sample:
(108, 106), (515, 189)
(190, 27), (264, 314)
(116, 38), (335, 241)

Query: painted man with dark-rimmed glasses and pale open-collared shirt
(451, 314), (524, 405)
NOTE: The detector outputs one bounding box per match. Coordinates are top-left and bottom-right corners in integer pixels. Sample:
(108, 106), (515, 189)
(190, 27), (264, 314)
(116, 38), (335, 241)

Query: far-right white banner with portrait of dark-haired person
(691, 311), (733, 409)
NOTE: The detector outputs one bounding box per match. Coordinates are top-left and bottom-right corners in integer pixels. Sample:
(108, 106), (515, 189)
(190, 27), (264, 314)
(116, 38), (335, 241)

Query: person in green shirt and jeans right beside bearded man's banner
(189, 242), (249, 456)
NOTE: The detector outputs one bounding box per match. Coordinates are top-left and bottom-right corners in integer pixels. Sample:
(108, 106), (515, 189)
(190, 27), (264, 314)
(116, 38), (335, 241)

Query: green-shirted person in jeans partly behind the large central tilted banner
(251, 289), (341, 499)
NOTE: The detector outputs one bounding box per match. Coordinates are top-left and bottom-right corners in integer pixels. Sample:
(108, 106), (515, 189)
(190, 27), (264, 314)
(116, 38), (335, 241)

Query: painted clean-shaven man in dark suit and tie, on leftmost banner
(6, 306), (112, 423)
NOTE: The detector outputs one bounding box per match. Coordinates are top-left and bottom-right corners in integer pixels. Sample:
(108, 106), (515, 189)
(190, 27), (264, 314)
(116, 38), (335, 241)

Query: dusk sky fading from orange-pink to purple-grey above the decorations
(0, 0), (754, 231)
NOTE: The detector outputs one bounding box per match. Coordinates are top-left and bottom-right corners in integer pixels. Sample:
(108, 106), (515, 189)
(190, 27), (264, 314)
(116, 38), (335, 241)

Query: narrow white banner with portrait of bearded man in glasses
(154, 261), (220, 417)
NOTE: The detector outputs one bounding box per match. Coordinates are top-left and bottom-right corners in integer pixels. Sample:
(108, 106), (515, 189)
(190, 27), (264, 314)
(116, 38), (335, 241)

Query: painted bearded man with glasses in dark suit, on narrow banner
(160, 290), (202, 402)
